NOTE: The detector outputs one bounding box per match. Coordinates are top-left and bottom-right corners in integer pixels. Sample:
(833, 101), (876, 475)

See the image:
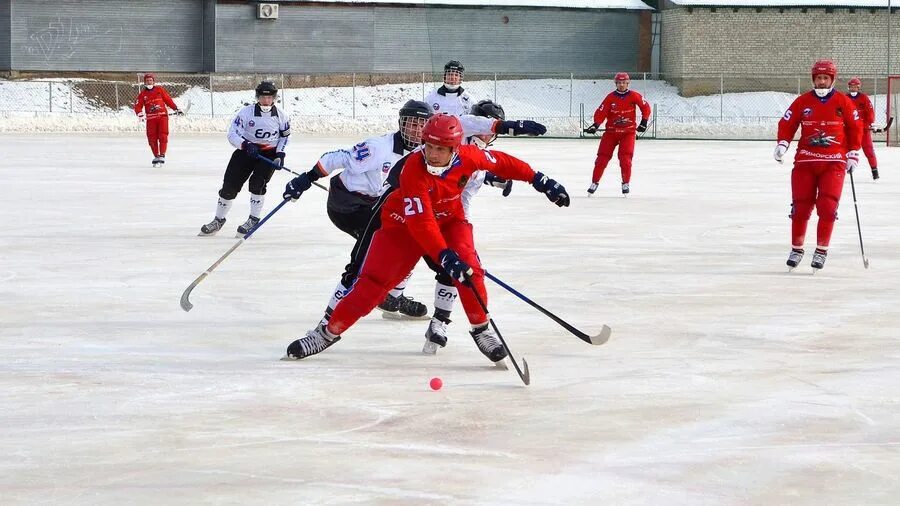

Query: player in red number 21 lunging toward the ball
(286, 114), (569, 362)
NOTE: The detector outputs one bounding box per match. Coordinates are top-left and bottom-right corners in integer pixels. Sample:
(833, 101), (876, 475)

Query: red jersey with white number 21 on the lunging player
(381, 145), (534, 261)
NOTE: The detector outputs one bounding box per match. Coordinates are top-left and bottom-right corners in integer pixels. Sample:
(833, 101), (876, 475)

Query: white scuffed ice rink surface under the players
(0, 134), (900, 505)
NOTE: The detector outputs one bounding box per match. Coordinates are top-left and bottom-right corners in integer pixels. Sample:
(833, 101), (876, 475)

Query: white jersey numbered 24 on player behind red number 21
(318, 115), (496, 197)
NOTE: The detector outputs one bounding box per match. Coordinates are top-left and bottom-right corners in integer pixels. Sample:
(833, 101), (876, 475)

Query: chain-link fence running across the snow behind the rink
(0, 73), (887, 139)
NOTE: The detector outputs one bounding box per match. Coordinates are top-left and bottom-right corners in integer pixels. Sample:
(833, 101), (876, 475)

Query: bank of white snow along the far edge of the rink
(0, 76), (887, 140)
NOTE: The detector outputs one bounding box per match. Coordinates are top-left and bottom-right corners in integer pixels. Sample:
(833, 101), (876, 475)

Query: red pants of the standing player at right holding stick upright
(791, 162), (847, 248)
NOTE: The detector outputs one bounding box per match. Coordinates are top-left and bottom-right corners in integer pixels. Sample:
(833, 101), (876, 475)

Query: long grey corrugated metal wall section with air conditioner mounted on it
(216, 3), (639, 73)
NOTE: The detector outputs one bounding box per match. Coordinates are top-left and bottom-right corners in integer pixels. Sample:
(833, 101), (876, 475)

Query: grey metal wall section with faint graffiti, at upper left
(10, 0), (203, 72)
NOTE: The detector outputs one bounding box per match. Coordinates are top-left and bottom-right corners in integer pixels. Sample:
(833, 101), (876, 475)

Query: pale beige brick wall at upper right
(660, 7), (900, 94)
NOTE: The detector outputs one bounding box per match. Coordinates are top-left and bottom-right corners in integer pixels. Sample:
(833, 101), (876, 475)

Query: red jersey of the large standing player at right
(778, 91), (862, 163)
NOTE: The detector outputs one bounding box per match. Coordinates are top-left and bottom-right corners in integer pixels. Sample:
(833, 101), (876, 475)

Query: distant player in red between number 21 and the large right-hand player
(584, 72), (650, 195)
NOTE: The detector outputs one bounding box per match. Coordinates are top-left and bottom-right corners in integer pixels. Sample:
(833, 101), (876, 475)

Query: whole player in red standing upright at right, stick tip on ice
(775, 60), (862, 270)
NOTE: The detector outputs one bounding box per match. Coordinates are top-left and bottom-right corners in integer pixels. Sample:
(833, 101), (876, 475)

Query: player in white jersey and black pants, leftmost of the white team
(200, 81), (291, 235)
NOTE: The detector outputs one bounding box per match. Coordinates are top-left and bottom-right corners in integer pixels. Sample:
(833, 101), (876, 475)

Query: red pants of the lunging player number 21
(328, 218), (488, 335)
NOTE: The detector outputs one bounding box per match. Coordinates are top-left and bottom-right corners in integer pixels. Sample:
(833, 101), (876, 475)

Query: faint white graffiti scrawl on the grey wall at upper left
(24, 17), (125, 62)
